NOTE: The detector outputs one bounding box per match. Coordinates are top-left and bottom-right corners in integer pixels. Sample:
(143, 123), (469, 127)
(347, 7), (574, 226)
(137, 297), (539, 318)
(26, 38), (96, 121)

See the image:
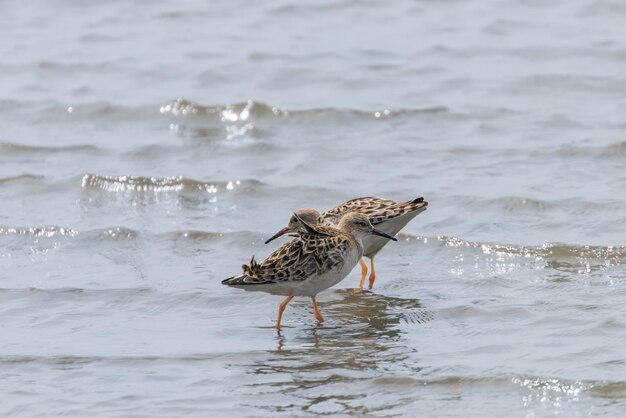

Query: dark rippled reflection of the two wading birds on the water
(236, 290), (433, 414)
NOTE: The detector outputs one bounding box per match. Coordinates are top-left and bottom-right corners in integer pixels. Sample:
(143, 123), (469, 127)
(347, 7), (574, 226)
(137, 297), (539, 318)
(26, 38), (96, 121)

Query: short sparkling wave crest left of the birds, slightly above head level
(81, 174), (262, 194)
